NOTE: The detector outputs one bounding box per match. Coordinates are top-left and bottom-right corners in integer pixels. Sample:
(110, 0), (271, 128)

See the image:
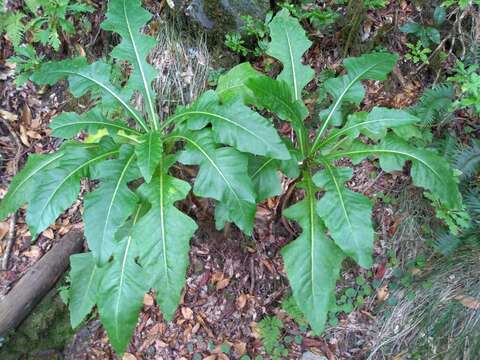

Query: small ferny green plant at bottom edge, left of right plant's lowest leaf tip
(258, 316), (288, 360)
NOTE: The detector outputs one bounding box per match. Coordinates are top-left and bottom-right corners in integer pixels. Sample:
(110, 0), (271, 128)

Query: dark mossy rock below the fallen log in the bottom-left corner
(0, 282), (74, 360)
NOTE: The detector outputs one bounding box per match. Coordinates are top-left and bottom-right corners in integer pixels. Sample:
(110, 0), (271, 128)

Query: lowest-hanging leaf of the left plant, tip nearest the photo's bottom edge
(97, 204), (150, 354)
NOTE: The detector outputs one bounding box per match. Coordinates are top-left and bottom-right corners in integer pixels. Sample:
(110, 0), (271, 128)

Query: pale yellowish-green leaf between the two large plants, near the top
(215, 62), (261, 103)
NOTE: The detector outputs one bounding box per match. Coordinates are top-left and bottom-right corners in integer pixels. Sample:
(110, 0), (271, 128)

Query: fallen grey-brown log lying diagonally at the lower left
(0, 231), (83, 336)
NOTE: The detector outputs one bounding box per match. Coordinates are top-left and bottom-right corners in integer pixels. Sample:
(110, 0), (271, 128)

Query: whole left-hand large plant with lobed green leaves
(0, 0), (291, 353)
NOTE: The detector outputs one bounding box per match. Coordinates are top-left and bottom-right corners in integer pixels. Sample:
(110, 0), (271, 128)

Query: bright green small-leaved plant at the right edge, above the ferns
(448, 61), (480, 114)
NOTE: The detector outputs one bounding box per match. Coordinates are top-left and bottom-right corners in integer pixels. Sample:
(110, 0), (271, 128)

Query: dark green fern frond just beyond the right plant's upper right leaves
(412, 84), (455, 126)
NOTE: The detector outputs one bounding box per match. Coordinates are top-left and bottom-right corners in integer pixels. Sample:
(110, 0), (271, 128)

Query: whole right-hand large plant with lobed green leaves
(217, 10), (461, 332)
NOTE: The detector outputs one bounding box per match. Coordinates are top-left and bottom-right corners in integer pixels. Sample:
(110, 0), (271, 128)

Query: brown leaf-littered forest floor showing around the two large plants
(0, 1), (478, 360)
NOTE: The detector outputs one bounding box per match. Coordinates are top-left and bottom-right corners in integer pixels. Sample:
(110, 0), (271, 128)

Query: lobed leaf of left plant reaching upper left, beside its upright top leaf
(32, 57), (148, 130)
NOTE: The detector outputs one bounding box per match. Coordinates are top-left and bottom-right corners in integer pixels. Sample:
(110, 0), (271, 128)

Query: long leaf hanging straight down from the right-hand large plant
(282, 174), (344, 333)
